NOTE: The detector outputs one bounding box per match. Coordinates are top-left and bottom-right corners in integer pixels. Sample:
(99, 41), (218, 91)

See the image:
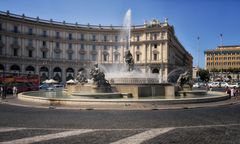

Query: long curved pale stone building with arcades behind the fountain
(0, 11), (193, 82)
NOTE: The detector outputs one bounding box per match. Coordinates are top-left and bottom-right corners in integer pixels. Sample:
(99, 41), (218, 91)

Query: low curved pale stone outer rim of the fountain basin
(18, 92), (230, 108)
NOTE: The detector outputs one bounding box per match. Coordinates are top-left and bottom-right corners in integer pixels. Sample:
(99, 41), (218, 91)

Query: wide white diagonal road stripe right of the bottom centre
(111, 128), (174, 144)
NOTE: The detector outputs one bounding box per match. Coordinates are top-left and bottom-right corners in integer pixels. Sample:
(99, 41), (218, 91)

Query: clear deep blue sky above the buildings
(0, 0), (240, 68)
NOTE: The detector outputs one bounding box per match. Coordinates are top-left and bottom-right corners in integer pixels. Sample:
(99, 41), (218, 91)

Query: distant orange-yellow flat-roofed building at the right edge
(204, 45), (240, 79)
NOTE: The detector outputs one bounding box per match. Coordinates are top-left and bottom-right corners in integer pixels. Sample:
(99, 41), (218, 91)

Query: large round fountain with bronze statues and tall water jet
(16, 10), (229, 108)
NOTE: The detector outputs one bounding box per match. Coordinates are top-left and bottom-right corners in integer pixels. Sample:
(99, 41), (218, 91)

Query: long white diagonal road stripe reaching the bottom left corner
(0, 129), (95, 144)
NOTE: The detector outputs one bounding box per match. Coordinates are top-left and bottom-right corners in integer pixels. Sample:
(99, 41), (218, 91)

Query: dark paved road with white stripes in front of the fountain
(0, 104), (240, 144)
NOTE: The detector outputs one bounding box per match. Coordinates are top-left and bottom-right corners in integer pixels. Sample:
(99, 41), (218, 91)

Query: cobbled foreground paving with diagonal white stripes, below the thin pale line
(0, 124), (240, 144)
